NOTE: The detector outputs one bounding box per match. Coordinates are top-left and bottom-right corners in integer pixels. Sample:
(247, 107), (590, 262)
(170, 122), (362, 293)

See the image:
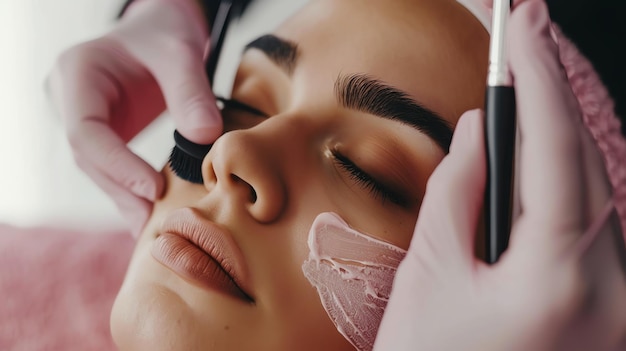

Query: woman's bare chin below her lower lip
(110, 247), (241, 351)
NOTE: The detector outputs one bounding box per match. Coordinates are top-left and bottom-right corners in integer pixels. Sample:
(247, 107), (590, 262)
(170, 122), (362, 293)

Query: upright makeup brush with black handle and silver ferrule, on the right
(485, 0), (516, 263)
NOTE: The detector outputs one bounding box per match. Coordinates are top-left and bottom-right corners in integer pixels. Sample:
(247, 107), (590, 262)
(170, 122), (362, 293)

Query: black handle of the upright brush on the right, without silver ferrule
(485, 86), (516, 263)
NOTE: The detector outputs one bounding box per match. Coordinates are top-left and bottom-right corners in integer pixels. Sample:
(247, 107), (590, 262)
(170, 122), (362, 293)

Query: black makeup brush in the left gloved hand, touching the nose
(169, 0), (251, 184)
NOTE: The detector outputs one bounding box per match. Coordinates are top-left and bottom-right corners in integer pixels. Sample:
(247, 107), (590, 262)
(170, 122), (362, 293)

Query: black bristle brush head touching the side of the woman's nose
(169, 130), (212, 184)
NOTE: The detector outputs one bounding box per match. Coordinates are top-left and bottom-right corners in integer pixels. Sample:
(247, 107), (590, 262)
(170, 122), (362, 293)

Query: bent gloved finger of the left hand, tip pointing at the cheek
(49, 49), (164, 201)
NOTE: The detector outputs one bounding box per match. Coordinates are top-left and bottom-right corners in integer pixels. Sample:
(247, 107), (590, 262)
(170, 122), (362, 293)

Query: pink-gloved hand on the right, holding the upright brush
(374, 0), (626, 351)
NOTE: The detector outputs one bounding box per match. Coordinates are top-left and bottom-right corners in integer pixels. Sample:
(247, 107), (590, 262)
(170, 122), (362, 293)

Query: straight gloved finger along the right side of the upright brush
(508, 0), (585, 239)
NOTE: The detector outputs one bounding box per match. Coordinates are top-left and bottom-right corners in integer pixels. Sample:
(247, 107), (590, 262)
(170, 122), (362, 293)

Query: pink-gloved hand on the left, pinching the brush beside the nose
(47, 0), (222, 235)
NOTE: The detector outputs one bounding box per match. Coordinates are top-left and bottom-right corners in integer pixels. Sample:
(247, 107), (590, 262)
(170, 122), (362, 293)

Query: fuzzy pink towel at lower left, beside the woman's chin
(0, 225), (134, 351)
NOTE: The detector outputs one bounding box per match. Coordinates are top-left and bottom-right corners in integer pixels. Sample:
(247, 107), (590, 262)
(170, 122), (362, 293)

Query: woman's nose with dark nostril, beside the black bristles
(202, 115), (310, 223)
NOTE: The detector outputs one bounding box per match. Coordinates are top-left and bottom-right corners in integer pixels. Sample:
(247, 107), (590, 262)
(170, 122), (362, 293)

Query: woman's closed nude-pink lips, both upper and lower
(152, 208), (253, 301)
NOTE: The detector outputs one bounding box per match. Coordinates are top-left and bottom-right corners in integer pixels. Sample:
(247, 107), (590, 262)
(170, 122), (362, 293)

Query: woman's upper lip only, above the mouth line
(161, 207), (254, 300)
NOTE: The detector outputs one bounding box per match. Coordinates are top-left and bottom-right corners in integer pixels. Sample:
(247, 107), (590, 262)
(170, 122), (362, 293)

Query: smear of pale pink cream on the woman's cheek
(302, 212), (406, 351)
